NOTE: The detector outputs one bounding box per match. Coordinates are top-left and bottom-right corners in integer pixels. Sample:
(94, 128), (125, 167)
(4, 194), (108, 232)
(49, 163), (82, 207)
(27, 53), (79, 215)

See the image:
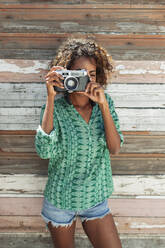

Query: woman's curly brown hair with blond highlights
(50, 38), (114, 86)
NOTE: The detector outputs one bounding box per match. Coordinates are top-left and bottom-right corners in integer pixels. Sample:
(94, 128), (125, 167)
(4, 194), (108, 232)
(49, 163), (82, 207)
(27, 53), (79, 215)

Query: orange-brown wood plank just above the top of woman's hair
(0, 33), (165, 50)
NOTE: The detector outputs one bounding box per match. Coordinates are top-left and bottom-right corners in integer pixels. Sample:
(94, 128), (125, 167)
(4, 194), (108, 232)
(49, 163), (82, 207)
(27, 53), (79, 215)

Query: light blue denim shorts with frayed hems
(41, 198), (111, 227)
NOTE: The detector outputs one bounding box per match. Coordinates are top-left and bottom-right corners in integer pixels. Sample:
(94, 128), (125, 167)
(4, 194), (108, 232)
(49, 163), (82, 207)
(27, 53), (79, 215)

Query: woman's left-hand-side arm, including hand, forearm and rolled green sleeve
(35, 67), (63, 159)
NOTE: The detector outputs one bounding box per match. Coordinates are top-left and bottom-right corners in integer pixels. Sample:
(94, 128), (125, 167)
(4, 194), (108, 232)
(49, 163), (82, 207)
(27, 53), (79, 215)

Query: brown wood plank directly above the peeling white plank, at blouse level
(0, 153), (165, 175)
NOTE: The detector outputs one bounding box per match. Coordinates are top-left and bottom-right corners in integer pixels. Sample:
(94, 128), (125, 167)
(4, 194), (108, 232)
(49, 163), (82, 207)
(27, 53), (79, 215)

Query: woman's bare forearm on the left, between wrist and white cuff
(41, 95), (54, 134)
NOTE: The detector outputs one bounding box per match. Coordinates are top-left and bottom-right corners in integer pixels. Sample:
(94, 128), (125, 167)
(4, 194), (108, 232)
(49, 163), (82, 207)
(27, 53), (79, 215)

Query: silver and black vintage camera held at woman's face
(54, 69), (90, 93)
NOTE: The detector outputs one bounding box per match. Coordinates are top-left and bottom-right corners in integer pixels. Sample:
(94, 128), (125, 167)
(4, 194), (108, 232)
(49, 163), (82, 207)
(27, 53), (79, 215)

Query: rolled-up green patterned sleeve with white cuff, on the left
(35, 105), (59, 159)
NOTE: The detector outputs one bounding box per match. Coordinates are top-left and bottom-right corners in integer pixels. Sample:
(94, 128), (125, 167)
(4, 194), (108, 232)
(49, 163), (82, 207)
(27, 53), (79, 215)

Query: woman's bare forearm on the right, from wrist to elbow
(99, 101), (121, 154)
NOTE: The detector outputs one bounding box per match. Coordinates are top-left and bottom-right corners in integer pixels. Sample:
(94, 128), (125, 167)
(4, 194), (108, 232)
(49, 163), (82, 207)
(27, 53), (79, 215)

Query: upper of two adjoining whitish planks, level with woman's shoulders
(0, 83), (165, 108)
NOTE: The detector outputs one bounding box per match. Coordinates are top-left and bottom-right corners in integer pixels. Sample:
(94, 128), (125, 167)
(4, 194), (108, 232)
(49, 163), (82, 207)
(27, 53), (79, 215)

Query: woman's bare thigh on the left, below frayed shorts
(48, 221), (76, 248)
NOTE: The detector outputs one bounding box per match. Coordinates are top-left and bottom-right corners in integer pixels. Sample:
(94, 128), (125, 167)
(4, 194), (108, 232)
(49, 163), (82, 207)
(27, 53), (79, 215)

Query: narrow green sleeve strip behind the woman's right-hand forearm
(106, 94), (124, 147)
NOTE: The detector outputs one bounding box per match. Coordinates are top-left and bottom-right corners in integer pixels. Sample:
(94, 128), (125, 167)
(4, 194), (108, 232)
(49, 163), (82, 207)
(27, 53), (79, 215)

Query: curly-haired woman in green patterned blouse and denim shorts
(35, 39), (123, 248)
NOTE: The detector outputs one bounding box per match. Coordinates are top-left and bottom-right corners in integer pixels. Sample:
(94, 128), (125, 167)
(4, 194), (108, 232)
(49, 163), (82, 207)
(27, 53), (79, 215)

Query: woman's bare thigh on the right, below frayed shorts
(82, 214), (122, 248)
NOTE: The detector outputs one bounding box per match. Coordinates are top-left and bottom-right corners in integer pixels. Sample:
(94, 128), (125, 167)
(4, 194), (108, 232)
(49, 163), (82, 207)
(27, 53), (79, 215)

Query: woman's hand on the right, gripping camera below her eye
(84, 82), (107, 106)
